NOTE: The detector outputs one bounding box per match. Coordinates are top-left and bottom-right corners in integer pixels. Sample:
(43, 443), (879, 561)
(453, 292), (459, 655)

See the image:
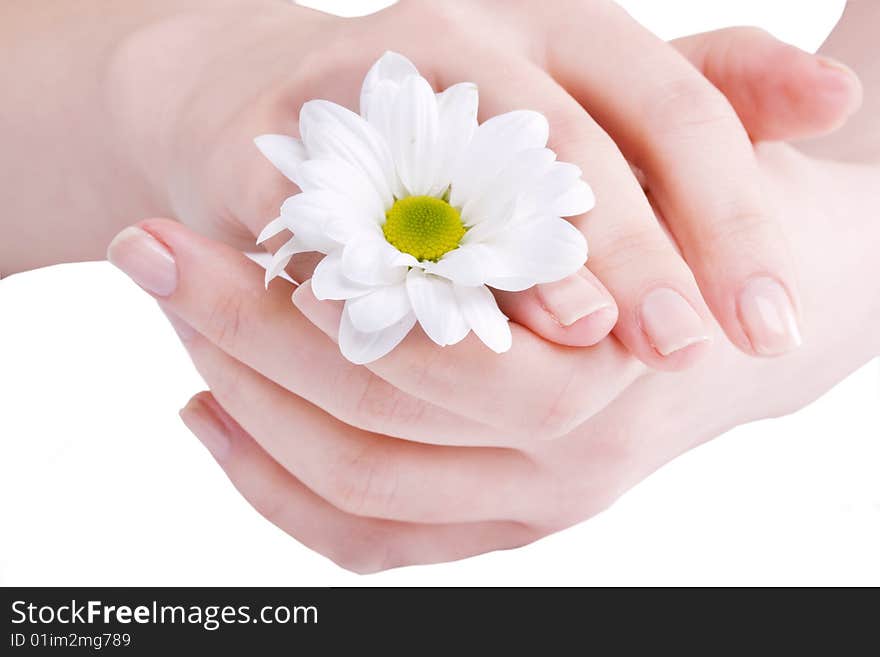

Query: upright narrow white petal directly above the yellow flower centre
(389, 75), (438, 196)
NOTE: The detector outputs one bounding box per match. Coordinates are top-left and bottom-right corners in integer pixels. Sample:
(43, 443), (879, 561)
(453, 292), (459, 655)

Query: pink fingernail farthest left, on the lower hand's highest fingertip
(107, 226), (177, 297)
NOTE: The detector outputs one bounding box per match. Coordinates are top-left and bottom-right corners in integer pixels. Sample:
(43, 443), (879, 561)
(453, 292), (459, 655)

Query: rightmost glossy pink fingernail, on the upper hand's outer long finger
(739, 276), (801, 356)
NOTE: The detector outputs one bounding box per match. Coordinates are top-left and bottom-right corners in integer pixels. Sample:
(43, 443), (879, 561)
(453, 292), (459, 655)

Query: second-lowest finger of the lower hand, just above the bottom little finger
(175, 336), (540, 522)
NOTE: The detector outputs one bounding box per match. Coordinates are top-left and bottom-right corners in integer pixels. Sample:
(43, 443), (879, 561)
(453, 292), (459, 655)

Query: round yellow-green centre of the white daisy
(382, 196), (466, 262)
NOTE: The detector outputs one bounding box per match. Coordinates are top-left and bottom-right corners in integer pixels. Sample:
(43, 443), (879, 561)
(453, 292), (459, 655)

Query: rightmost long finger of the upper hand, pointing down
(549, 3), (800, 356)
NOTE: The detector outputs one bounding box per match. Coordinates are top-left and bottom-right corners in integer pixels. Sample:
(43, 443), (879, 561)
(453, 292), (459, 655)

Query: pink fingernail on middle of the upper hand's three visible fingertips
(639, 287), (709, 356)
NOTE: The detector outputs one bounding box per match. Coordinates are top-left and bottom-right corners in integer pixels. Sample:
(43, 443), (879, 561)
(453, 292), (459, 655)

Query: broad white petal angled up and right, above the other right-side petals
(454, 110), (550, 207)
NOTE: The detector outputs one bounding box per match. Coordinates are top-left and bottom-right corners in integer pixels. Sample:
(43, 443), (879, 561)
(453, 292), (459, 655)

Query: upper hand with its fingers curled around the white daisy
(98, 0), (858, 369)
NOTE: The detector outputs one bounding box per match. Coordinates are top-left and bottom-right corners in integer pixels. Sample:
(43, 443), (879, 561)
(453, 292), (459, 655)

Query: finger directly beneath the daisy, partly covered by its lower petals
(293, 281), (643, 439)
